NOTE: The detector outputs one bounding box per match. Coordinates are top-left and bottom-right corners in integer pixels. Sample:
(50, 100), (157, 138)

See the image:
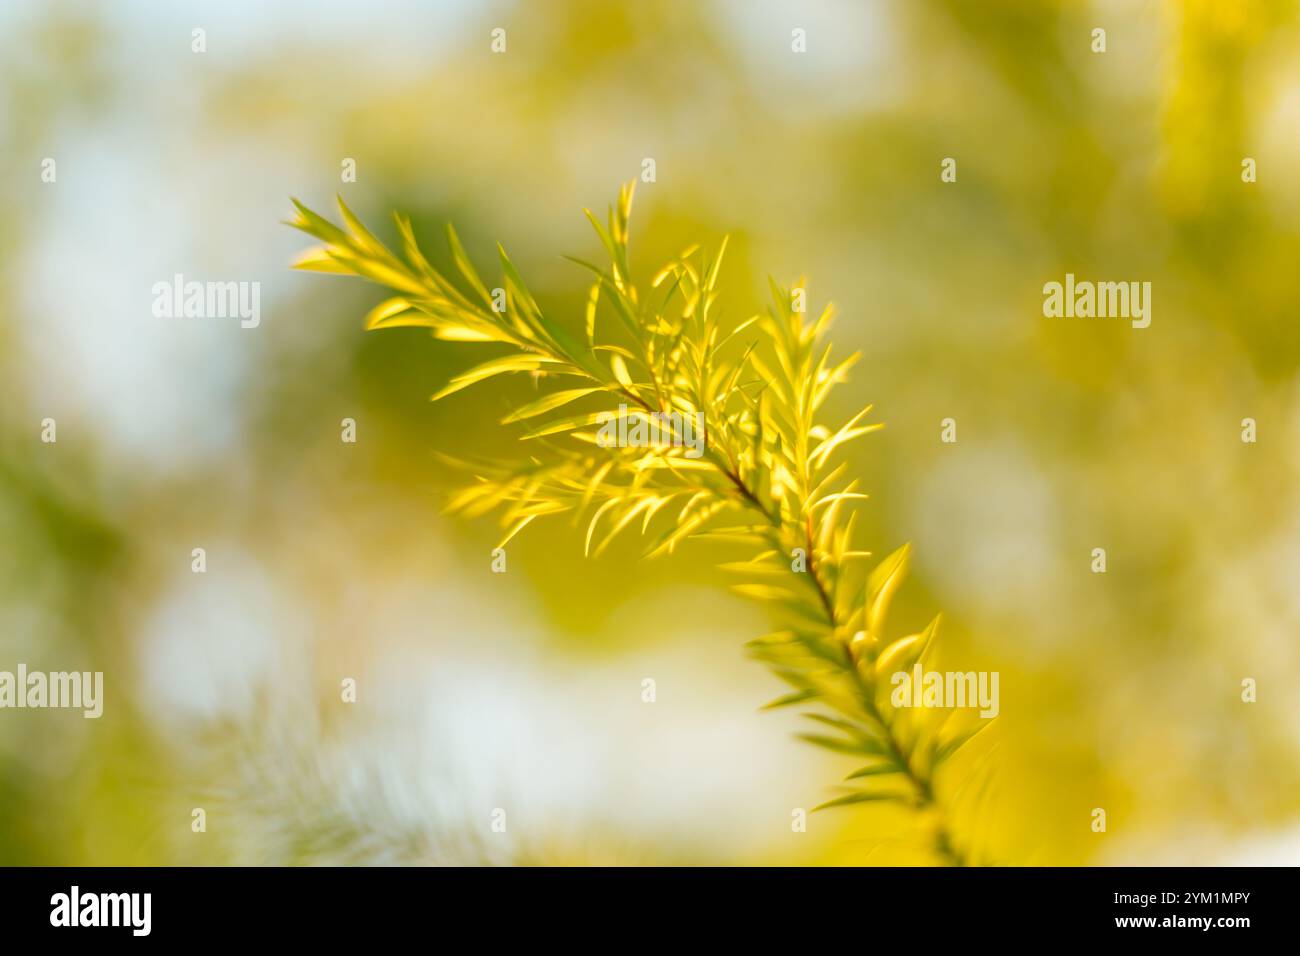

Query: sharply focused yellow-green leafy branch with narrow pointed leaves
(291, 183), (988, 864)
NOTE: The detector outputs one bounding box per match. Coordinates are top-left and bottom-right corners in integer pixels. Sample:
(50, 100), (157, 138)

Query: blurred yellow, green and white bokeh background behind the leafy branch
(0, 0), (1300, 865)
